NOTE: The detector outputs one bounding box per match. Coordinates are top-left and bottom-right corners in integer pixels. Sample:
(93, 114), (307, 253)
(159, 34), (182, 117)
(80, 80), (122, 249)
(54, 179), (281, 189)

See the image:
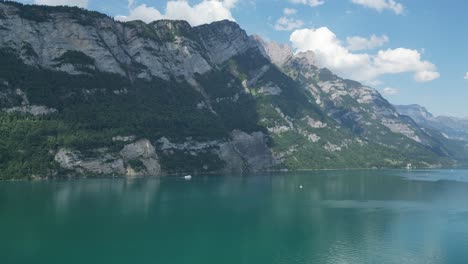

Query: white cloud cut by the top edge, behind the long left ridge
(115, 0), (237, 26)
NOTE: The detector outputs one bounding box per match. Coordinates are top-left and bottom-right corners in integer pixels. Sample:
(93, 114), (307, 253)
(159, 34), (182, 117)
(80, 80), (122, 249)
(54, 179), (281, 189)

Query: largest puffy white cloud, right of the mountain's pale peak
(290, 27), (440, 82)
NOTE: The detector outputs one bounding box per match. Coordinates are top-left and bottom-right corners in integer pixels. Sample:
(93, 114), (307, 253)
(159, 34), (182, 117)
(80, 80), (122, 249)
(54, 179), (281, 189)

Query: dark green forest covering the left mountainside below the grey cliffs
(0, 50), (241, 178)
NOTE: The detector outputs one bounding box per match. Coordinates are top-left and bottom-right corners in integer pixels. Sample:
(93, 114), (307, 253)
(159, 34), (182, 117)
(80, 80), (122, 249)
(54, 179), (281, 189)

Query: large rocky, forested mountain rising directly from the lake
(0, 1), (459, 178)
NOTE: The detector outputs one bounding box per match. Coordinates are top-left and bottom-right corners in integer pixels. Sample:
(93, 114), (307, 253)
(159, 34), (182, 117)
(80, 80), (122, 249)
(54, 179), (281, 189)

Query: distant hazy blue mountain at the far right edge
(395, 104), (468, 142)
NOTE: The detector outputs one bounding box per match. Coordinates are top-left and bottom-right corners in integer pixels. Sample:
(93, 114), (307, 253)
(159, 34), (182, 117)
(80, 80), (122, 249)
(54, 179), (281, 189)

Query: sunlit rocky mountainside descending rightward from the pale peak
(260, 41), (460, 163)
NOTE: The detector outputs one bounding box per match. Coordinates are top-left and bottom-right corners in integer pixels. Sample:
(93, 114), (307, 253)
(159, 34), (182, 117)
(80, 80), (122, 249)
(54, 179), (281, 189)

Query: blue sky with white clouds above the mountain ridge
(12, 0), (468, 117)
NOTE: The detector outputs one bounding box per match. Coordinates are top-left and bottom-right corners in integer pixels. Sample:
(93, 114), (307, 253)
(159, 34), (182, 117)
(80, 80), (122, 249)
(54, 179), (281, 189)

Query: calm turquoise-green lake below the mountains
(0, 170), (468, 264)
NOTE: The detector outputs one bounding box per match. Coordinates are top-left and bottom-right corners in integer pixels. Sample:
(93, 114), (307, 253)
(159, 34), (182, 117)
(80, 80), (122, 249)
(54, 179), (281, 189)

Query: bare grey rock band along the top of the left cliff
(0, 3), (253, 80)
